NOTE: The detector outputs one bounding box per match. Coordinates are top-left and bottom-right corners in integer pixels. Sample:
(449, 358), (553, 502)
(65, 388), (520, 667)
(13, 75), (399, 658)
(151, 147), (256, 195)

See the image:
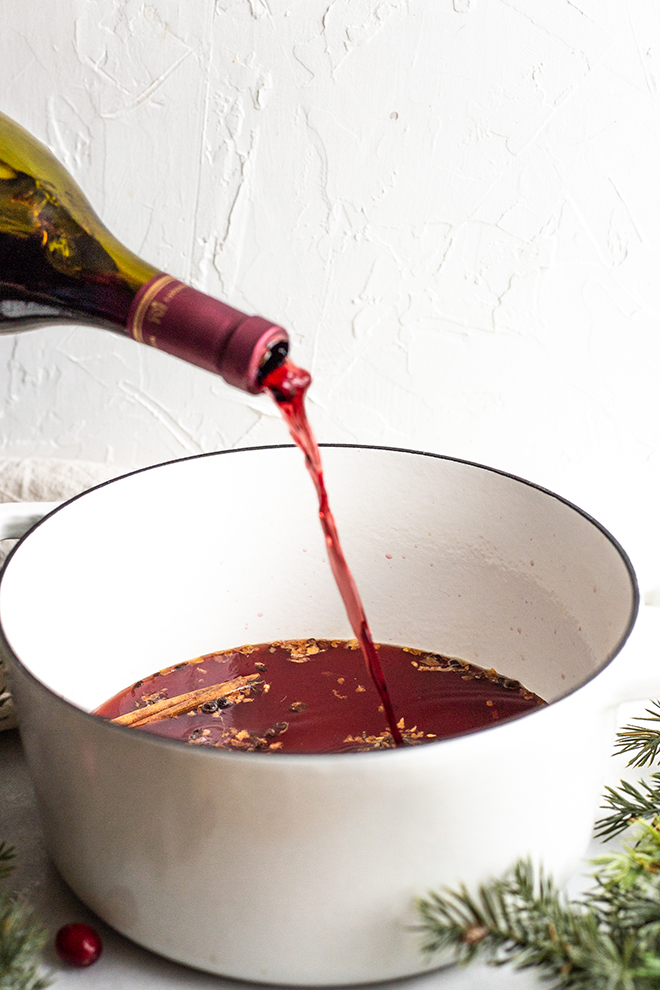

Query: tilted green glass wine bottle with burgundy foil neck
(0, 113), (288, 392)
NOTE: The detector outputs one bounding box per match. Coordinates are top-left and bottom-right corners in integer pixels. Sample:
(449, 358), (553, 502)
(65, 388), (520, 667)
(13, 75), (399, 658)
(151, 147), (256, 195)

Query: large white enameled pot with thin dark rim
(0, 446), (648, 985)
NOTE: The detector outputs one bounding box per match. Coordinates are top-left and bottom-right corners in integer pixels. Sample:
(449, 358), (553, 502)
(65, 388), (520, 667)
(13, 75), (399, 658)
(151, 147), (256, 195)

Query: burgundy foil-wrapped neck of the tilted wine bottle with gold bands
(126, 273), (288, 393)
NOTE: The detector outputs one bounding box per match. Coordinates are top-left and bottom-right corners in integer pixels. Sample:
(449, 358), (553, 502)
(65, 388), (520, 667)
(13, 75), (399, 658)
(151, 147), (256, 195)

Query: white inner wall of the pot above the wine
(0, 446), (637, 709)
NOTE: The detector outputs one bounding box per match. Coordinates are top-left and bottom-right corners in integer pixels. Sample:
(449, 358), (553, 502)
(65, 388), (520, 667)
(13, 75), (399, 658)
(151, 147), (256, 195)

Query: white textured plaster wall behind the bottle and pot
(0, 0), (660, 588)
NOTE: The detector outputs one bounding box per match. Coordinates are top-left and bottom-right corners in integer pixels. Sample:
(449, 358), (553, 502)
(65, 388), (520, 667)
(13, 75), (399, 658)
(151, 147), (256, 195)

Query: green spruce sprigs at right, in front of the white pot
(418, 702), (660, 990)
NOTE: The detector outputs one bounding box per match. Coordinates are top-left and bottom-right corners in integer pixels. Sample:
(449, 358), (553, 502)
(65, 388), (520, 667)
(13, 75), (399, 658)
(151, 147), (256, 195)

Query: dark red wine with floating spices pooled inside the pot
(95, 639), (544, 753)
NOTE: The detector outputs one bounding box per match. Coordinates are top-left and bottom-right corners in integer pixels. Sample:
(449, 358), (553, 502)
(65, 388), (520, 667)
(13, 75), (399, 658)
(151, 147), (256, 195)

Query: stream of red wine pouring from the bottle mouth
(262, 358), (404, 746)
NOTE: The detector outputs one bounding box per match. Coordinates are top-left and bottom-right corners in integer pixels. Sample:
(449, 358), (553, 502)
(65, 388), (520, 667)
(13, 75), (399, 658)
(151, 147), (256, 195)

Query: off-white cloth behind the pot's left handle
(0, 457), (124, 730)
